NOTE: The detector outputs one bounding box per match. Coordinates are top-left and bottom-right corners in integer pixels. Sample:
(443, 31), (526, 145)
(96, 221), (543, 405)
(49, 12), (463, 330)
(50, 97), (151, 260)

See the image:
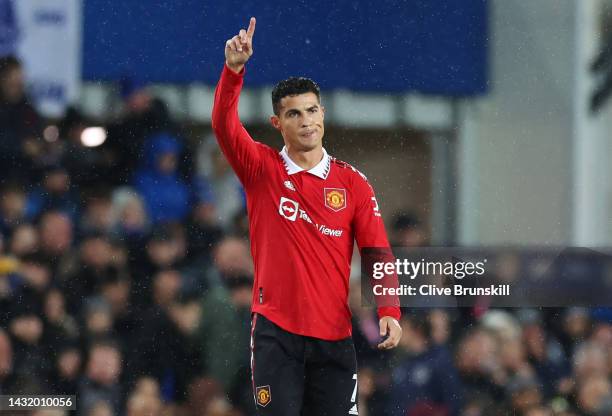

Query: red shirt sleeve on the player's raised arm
(212, 65), (263, 187)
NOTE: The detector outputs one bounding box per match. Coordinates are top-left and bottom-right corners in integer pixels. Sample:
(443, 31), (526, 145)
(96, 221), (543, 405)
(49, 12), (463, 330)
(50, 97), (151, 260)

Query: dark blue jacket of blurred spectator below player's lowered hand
(386, 346), (463, 416)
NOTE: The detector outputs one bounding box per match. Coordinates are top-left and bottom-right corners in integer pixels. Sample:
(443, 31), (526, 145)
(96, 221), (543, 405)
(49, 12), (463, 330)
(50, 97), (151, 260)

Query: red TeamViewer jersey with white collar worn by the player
(212, 66), (400, 340)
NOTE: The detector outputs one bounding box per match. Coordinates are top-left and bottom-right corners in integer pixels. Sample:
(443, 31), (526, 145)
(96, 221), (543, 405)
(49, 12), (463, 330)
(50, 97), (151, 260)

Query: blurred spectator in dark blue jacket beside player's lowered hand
(387, 313), (463, 416)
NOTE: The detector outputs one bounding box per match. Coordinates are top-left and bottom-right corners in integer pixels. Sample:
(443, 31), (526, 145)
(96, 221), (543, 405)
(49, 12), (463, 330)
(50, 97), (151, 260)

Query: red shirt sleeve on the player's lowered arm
(353, 173), (401, 319)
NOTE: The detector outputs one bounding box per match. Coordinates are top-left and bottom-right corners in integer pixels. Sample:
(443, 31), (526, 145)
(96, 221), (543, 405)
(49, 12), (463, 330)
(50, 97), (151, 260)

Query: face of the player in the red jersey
(270, 92), (325, 152)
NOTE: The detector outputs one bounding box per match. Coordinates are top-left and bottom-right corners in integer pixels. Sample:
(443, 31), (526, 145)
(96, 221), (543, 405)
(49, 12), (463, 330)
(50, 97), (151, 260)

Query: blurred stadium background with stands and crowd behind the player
(0, 0), (612, 416)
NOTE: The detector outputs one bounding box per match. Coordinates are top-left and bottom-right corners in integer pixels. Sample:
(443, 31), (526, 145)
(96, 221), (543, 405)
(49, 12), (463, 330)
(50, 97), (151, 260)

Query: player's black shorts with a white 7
(251, 314), (358, 416)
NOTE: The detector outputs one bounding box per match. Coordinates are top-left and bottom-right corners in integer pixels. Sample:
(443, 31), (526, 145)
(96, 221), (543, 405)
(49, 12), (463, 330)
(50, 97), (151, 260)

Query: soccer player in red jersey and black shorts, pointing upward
(212, 18), (401, 416)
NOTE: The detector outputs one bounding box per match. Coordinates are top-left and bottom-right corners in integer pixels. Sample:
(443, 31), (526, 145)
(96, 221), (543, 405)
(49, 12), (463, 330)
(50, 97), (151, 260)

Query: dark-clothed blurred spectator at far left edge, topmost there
(0, 56), (42, 181)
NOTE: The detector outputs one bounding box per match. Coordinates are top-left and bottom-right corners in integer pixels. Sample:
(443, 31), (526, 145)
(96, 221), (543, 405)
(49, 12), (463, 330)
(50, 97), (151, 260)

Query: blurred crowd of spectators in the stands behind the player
(0, 57), (612, 416)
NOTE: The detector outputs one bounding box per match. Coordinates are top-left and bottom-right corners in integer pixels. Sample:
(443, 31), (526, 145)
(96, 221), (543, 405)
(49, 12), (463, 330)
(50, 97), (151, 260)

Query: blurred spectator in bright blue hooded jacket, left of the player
(133, 133), (192, 224)
